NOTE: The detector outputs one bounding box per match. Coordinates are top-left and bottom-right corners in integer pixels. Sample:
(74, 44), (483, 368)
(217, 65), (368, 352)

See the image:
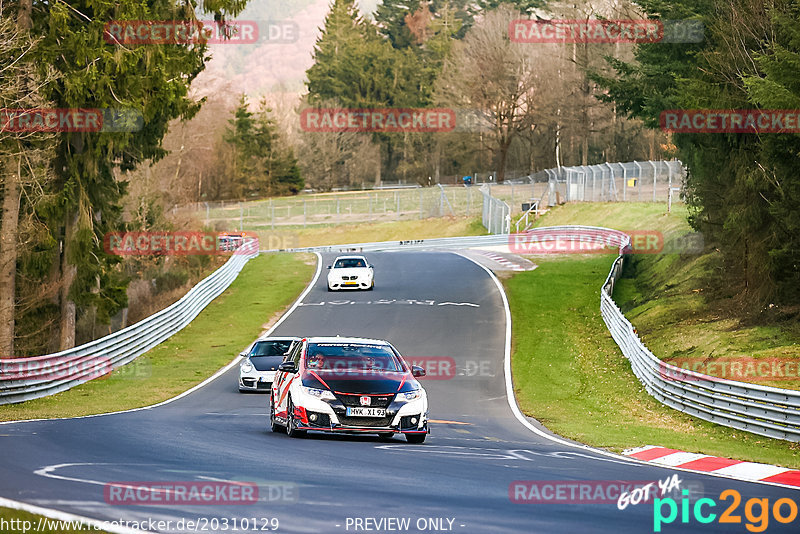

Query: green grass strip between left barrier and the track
(0, 254), (316, 421)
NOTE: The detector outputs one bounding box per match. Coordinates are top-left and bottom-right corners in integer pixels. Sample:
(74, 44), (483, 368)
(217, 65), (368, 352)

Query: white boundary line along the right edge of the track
(454, 252), (800, 490)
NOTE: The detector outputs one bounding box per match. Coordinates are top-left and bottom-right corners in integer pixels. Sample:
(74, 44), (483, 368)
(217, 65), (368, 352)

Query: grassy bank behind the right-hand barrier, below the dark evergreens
(614, 252), (800, 389)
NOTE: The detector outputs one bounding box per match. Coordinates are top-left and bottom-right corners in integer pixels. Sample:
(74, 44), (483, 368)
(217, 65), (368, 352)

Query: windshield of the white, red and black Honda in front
(306, 343), (403, 372)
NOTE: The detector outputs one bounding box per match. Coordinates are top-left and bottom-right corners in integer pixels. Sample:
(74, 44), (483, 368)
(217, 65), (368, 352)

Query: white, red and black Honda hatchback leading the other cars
(270, 337), (428, 443)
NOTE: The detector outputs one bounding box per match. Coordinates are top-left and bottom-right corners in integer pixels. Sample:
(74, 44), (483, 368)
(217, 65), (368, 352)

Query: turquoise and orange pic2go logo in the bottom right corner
(653, 489), (797, 532)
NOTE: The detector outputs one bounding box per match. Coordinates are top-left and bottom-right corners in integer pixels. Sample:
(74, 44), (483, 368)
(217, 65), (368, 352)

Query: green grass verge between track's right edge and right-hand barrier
(505, 255), (800, 468)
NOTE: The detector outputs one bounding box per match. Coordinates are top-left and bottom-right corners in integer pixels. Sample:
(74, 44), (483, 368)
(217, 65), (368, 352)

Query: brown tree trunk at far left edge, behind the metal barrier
(0, 155), (22, 358)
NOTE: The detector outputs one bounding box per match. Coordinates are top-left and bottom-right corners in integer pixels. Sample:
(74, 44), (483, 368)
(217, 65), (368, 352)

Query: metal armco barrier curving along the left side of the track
(0, 240), (258, 404)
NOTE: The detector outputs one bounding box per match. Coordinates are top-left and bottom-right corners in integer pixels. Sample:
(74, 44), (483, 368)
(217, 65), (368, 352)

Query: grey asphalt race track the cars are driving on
(0, 252), (800, 534)
